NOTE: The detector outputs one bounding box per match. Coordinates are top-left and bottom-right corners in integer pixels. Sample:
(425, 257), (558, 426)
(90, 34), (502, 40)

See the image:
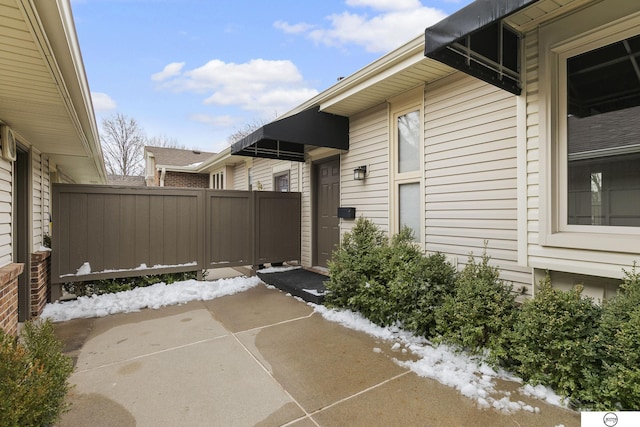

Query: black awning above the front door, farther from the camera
(231, 108), (349, 162)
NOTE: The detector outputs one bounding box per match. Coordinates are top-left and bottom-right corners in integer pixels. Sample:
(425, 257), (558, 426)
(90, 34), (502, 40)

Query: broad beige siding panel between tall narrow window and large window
(425, 73), (532, 293)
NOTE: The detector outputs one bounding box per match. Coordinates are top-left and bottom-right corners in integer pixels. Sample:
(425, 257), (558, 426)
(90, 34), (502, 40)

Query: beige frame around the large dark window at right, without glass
(539, 5), (640, 252)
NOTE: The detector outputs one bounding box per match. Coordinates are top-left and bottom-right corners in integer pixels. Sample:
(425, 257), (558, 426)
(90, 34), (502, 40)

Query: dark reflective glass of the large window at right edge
(565, 35), (640, 227)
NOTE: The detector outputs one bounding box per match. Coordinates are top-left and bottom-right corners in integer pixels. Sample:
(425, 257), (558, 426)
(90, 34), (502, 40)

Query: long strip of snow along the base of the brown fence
(41, 277), (261, 322)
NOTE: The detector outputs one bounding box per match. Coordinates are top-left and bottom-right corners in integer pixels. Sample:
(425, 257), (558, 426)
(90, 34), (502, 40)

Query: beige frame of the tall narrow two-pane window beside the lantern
(389, 86), (425, 249)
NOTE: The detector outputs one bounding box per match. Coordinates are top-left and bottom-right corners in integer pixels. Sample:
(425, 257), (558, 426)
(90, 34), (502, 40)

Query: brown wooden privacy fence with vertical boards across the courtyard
(51, 184), (301, 283)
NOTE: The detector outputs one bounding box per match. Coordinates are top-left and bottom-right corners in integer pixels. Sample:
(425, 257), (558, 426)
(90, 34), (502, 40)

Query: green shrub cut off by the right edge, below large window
(583, 264), (640, 411)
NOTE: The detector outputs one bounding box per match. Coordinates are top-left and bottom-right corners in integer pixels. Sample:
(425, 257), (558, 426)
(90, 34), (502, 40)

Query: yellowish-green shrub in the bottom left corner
(0, 321), (73, 427)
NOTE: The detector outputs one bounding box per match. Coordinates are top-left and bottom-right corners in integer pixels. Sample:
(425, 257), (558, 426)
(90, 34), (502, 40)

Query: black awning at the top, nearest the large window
(425, 0), (538, 95)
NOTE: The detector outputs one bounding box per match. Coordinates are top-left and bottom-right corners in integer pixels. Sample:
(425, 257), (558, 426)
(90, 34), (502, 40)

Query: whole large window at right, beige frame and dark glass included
(539, 10), (640, 252)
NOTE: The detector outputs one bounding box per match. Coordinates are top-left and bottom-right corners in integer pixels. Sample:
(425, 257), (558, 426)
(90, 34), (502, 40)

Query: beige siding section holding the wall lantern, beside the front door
(340, 104), (389, 233)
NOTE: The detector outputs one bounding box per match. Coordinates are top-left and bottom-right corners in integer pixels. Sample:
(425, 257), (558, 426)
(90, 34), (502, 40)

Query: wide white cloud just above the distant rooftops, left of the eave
(156, 59), (318, 114)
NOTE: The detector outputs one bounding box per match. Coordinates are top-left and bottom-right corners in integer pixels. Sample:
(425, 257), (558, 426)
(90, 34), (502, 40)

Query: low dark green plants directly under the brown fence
(64, 271), (197, 297)
